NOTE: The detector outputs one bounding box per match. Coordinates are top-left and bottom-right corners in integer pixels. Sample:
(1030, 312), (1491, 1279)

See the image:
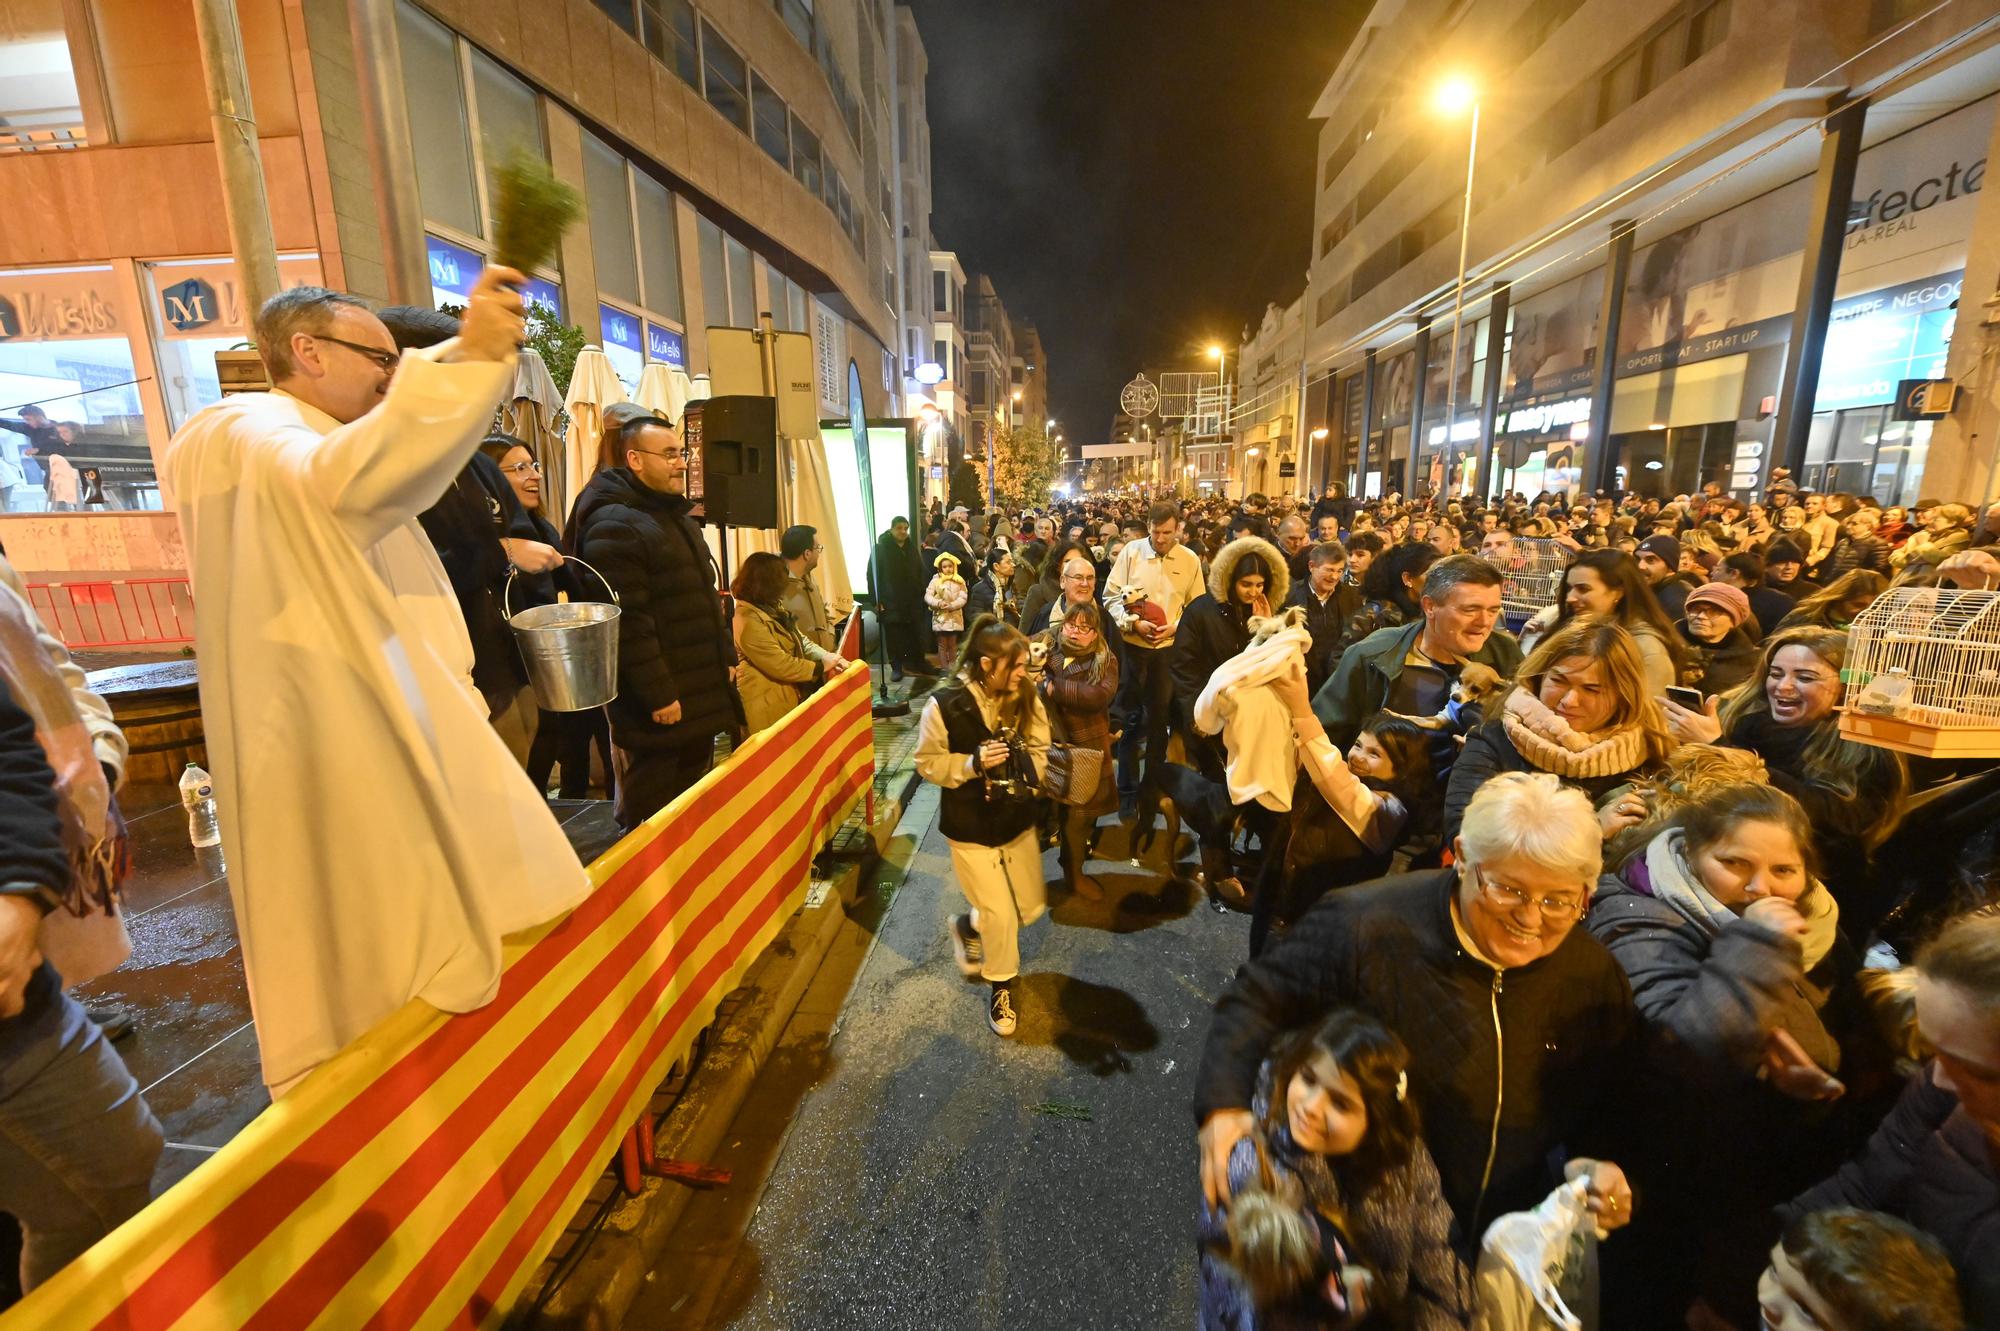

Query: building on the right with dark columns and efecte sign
(1304, 0), (2000, 504)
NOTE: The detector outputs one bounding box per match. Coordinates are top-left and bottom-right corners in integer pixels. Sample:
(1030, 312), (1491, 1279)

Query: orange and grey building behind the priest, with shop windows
(0, 0), (930, 574)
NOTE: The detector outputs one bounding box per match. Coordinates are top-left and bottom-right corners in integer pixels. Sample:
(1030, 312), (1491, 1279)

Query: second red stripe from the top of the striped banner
(242, 735), (872, 1331)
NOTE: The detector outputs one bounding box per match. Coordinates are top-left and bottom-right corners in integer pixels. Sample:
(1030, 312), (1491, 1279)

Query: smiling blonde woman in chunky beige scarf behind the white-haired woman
(1444, 616), (1674, 837)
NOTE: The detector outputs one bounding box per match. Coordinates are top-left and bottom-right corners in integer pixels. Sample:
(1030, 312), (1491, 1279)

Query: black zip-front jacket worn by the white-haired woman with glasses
(1194, 869), (1636, 1241)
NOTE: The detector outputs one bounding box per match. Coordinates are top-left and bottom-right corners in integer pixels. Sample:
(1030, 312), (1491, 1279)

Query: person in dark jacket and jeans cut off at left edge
(0, 683), (166, 1289)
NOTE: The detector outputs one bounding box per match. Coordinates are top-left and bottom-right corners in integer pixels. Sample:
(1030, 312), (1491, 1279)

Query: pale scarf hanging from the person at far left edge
(0, 588), (132, 985)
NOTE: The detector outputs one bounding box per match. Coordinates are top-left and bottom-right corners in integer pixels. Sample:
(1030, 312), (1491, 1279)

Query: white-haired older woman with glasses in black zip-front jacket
(1194, 771), (1636, 1247)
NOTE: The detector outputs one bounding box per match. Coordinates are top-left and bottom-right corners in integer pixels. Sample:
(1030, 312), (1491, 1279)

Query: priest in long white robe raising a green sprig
(166, 270), (588, 1095)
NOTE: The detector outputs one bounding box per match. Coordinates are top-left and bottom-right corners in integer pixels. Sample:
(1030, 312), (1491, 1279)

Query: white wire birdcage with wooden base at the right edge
(1840, 588), (2000, 757)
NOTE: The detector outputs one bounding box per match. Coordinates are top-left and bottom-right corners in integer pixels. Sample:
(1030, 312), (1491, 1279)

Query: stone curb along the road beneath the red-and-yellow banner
(532, 771), (920, 1331)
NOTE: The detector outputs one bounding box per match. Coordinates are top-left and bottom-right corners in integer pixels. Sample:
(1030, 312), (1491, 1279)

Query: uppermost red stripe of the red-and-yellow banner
(98, 693), (868, 1331)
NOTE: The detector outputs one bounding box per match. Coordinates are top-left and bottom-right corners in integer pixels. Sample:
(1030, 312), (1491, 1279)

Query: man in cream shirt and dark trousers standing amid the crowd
(1104, 502), (1204, 809)
